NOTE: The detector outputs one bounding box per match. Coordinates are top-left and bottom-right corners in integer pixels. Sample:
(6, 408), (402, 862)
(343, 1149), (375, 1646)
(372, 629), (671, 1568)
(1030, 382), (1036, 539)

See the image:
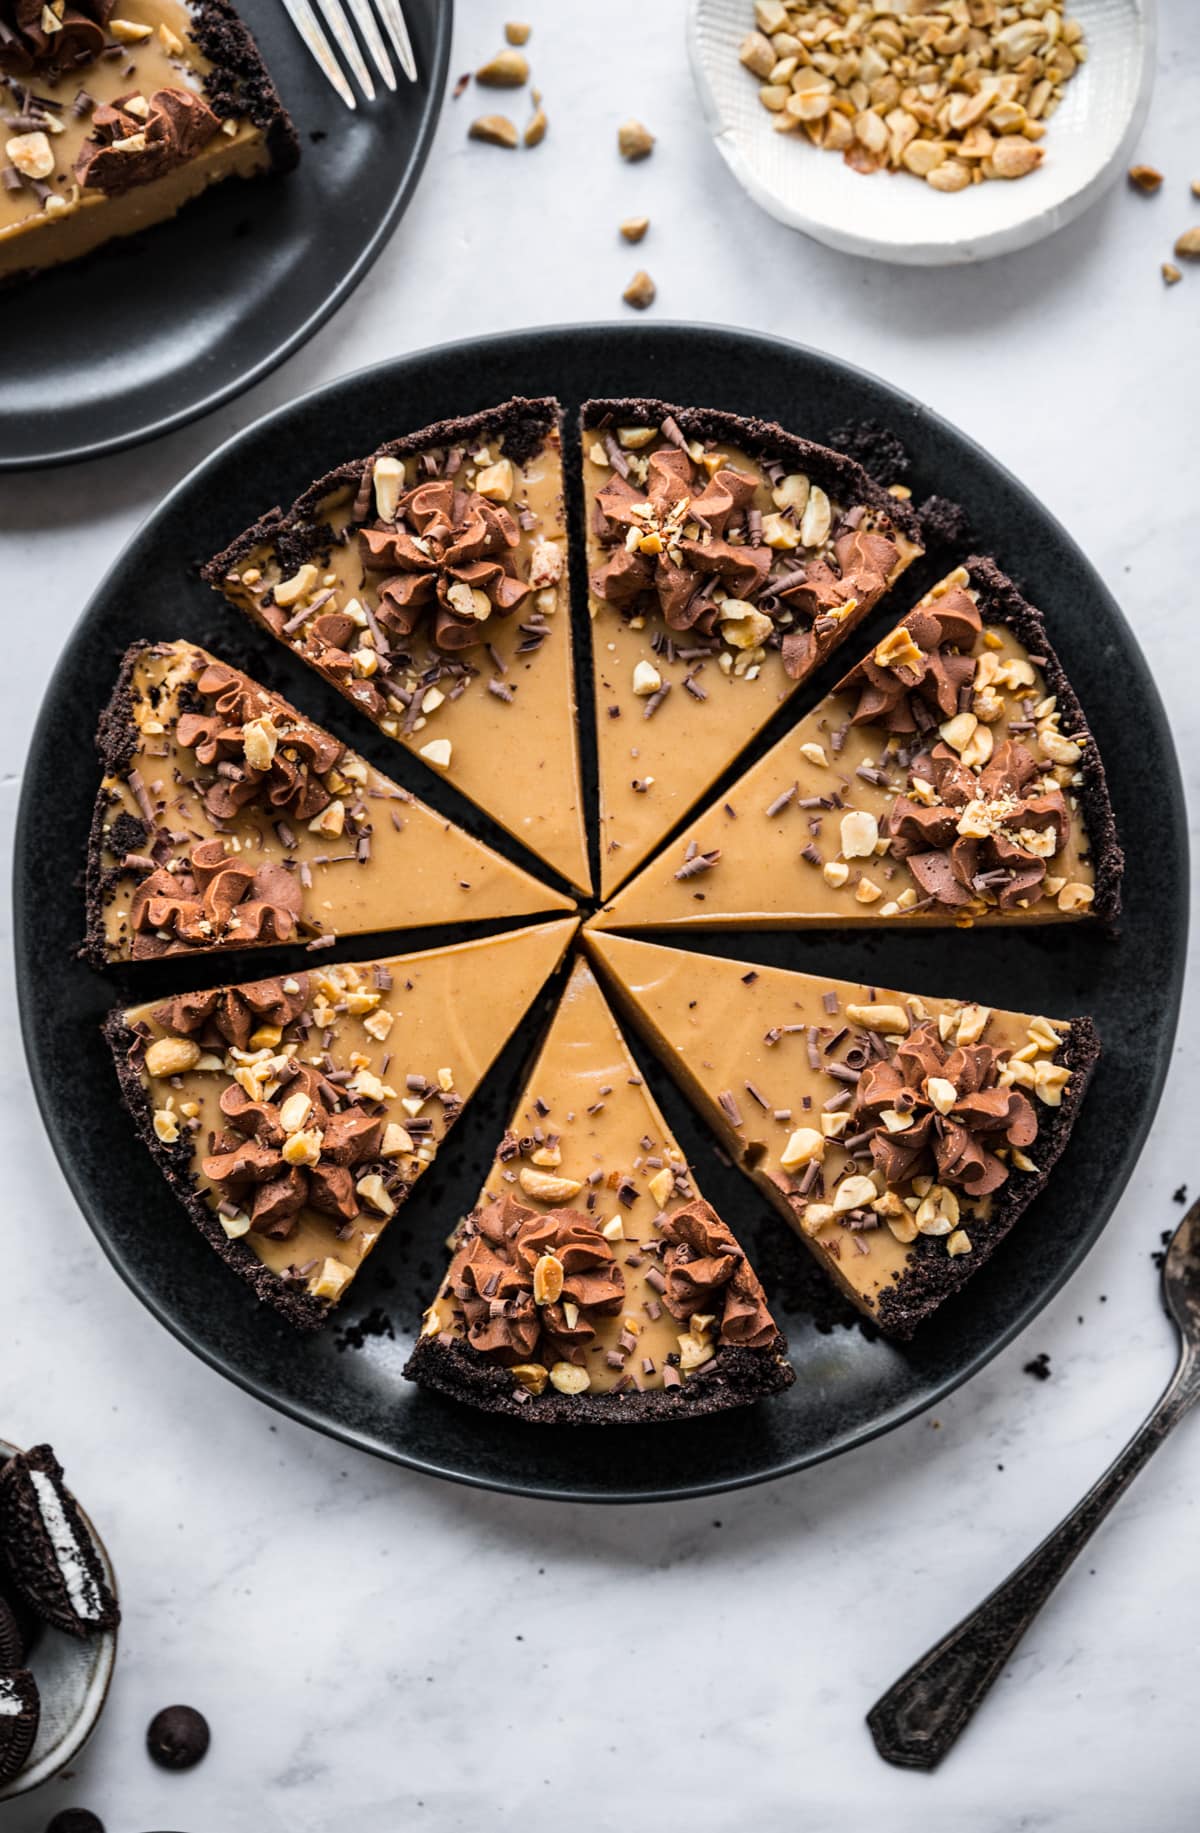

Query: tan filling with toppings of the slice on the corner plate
(0, 0), (269, 275)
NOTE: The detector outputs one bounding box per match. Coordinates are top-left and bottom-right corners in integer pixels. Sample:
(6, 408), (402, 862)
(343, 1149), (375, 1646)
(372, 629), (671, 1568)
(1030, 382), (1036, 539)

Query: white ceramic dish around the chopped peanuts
(687, 0), (1156, 268)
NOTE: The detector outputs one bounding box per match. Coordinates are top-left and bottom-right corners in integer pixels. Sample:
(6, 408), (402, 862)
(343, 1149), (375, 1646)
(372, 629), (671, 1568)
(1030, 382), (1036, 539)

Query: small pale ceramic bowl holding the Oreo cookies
(0, 1439), (117, 1802)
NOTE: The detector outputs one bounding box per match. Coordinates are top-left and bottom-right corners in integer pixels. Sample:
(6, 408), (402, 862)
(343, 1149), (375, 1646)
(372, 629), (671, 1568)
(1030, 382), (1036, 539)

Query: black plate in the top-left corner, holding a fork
(0, 0), (453, 471)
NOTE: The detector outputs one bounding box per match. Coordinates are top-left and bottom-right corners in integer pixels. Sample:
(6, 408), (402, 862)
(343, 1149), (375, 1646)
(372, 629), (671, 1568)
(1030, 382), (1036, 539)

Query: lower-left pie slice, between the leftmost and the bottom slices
(106, 920), (575, 1329)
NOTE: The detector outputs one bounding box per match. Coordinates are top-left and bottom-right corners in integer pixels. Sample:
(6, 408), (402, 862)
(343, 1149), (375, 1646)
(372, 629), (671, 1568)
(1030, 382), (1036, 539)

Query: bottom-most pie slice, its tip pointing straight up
(405, 960), (793, 1424)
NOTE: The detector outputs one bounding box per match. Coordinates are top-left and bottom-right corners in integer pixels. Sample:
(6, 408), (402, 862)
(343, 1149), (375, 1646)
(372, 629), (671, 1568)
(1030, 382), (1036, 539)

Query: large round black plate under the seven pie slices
(16, 324), (1187, 1501)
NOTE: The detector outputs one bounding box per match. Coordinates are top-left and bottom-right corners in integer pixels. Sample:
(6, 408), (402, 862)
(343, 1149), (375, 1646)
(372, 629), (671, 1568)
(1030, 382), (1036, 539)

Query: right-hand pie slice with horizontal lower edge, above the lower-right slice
(595, 557), (1123, 929)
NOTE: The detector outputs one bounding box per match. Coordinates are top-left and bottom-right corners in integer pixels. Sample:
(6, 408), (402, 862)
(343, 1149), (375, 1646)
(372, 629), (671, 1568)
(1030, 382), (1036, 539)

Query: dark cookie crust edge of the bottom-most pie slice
(405, 1334), (795, 1426)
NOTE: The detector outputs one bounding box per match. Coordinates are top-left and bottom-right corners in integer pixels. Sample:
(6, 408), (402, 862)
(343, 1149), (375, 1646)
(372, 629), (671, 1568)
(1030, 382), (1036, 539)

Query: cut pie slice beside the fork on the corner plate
(0, 0), (299, 280)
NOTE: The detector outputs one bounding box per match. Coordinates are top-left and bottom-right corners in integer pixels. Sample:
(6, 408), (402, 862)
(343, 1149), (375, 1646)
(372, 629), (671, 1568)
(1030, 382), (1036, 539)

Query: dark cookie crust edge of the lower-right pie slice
(876, 1017), (1099, 1342)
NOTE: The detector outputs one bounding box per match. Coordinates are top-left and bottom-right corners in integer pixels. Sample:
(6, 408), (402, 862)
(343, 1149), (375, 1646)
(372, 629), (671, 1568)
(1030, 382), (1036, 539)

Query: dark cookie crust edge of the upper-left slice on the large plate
(200, 394), (561, 590)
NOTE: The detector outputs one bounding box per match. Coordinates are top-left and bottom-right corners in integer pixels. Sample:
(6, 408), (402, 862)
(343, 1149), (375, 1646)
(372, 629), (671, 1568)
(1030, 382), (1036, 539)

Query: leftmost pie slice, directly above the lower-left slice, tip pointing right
(88, 642), (572, 966)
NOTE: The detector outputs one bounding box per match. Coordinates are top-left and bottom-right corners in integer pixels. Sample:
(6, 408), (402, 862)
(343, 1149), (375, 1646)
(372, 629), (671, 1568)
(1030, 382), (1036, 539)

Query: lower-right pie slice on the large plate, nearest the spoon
(590, 935), (1099, 1338)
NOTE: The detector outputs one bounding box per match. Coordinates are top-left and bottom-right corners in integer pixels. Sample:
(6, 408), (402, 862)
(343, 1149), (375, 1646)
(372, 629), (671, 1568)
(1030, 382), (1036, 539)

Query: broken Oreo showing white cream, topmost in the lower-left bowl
(0, 1444), (121, 1637)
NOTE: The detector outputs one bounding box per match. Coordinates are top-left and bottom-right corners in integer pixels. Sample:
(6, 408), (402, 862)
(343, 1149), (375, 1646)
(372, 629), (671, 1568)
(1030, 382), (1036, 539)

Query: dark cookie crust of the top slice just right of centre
(579, 396), (922, 546)
